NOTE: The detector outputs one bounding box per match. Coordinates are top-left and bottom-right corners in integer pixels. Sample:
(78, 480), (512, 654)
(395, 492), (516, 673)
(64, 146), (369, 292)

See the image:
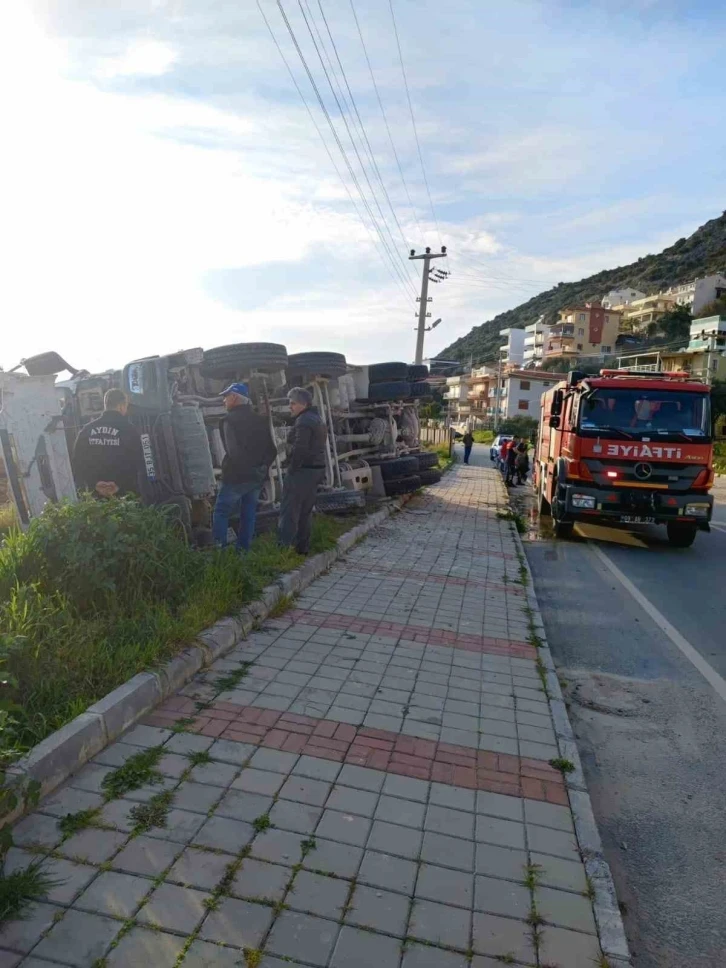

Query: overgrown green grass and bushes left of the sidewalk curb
(0, 498), (351, 763)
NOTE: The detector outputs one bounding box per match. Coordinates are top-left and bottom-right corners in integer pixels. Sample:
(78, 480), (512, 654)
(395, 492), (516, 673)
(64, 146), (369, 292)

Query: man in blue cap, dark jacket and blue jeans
(212, 383), (276, 551)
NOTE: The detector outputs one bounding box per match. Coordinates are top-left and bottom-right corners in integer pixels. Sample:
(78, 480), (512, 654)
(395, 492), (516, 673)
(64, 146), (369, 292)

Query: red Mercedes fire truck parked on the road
(534, 370), (713, 548)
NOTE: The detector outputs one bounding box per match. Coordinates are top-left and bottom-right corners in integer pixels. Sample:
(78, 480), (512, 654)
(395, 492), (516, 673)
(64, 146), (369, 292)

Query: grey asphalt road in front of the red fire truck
(510, 458), (726, 968)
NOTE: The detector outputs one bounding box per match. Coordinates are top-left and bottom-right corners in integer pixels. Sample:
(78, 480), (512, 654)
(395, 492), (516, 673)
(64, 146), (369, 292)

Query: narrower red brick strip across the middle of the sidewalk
(284, 608), (537, 659)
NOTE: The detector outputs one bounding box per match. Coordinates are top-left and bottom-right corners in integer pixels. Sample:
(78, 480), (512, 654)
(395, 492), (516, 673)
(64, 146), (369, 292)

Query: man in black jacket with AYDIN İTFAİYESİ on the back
(73, 390), (144, 497)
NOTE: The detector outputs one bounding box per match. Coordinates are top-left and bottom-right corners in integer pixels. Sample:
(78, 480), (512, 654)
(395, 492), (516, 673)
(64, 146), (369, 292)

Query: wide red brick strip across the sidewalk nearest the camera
(145, 696), (568, 806)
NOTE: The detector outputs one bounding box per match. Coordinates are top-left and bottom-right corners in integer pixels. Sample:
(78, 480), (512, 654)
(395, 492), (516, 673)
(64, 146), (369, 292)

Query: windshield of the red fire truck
(579, 387), (711, 440)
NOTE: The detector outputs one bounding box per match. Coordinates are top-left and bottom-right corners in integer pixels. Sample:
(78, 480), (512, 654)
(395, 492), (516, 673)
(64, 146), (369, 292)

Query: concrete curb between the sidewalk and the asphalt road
(514, 528), (632, 968)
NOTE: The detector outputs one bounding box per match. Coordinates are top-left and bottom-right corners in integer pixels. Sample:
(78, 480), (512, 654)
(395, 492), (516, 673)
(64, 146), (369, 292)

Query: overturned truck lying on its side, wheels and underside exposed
(0, 343), (438, 545)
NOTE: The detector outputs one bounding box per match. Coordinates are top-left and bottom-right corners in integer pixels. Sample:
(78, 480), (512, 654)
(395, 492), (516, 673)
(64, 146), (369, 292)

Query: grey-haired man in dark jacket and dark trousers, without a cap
(278, 387), (328, 555)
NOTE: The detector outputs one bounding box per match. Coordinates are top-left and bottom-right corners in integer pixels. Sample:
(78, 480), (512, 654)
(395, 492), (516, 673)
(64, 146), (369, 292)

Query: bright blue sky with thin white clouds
(0, 0), (726, 371)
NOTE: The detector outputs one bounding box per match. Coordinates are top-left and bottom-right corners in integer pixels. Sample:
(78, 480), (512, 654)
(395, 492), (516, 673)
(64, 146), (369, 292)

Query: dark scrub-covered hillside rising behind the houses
(438, 212), (726, 361)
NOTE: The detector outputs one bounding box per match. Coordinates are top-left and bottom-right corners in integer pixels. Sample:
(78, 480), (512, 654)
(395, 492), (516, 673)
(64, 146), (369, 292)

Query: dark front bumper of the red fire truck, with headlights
(559, 484), (713, 531)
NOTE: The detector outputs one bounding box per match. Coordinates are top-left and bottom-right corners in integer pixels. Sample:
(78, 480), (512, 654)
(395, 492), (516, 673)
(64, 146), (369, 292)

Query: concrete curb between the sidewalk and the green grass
(0, 494), (412, 826)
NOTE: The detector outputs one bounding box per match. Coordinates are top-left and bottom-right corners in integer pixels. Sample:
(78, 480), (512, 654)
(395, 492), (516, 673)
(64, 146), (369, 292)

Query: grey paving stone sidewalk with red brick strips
(0, 466), (605, 968)
